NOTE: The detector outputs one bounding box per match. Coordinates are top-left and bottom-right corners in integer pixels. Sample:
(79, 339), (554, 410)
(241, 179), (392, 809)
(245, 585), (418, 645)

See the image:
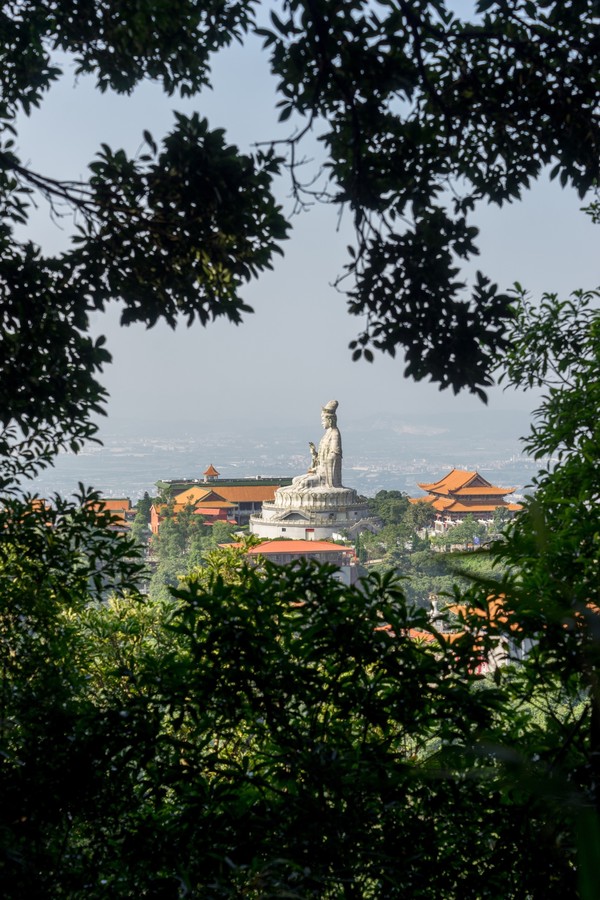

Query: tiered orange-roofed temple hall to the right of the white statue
(410, 469), (521, 531)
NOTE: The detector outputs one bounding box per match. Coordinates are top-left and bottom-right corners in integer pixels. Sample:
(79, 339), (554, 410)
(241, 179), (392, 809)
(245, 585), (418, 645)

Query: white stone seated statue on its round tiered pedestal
(250, 400), (369, 541)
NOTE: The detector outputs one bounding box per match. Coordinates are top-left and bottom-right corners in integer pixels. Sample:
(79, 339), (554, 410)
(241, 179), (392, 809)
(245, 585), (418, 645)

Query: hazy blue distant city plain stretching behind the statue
(32, 411), (538, 502)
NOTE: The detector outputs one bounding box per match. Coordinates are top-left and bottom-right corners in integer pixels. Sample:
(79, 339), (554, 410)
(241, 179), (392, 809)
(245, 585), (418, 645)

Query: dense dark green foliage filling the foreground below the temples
(0, 548), (587, 898)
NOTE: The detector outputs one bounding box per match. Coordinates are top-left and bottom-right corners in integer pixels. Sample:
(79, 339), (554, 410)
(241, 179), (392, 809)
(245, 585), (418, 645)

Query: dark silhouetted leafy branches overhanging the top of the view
(0, 0), (600, 458)
